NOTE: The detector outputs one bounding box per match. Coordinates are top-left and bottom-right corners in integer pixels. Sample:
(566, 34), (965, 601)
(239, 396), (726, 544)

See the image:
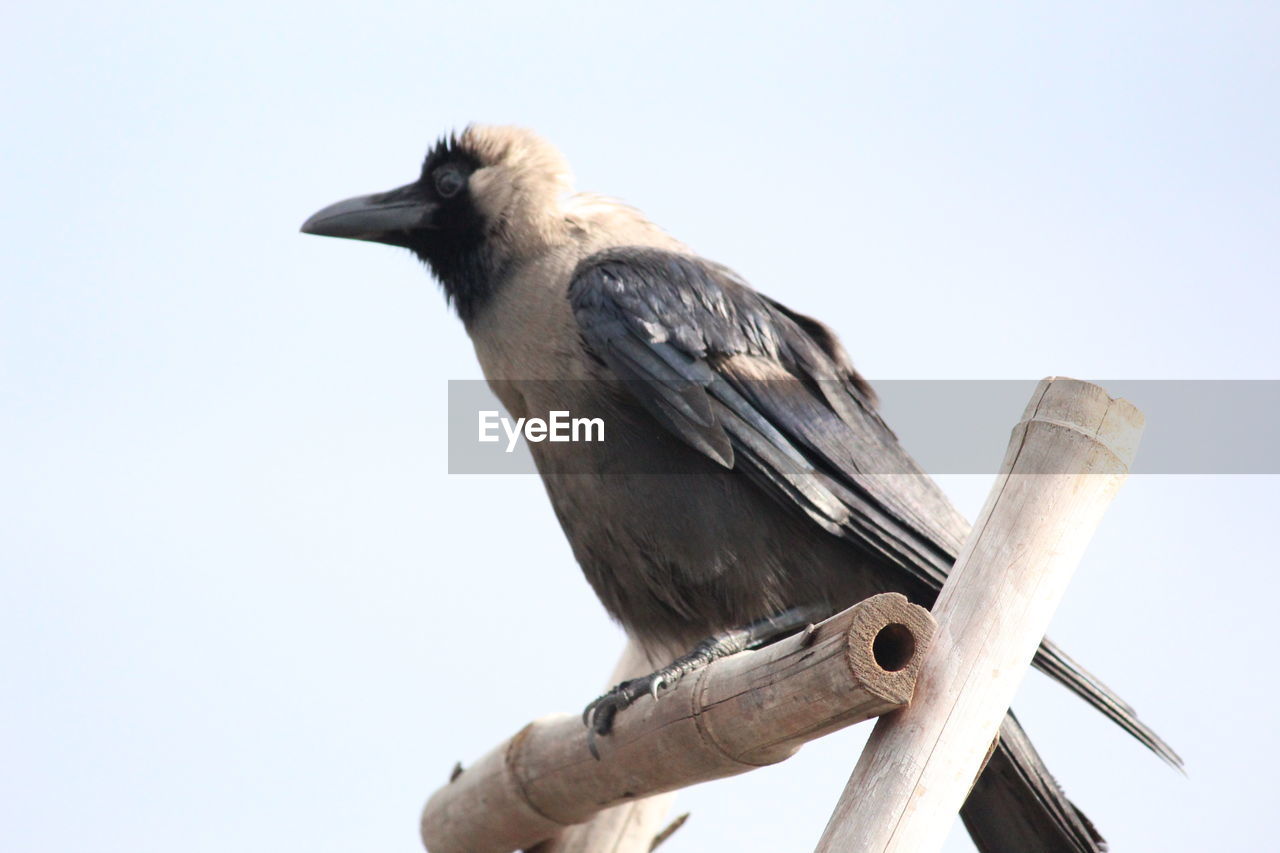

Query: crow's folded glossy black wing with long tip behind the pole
(568, 247), (1181, 766)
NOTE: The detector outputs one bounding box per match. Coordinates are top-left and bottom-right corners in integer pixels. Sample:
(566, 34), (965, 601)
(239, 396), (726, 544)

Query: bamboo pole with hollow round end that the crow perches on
(422, 593), (933, 853)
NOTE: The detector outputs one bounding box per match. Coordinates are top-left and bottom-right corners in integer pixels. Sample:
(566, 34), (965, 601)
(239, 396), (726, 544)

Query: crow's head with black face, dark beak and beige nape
(302, 126), (570, 319)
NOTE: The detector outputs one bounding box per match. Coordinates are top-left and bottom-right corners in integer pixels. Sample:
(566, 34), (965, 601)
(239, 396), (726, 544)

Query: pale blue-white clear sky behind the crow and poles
(0, 0), (1280, 853)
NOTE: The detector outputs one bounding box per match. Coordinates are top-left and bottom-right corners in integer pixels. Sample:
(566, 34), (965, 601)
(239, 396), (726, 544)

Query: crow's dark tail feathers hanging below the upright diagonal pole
(960, 713), (1107, 853)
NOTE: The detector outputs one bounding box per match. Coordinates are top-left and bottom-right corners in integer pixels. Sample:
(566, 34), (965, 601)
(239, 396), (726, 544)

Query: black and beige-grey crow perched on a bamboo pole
(302, 124), (1181, 853)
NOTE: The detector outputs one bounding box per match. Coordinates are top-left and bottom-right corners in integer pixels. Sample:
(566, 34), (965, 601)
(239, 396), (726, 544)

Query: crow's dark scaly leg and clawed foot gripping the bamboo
(582, 607), (828, 758)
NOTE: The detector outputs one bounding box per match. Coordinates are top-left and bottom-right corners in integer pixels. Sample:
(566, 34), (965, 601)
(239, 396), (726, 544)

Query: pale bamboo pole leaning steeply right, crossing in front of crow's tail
(818, 379), (1143, 853)
